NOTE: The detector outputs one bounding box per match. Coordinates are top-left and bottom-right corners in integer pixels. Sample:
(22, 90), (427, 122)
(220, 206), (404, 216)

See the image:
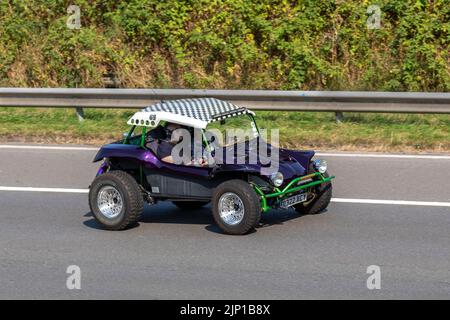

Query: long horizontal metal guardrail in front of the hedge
(0, 88), (450, 114)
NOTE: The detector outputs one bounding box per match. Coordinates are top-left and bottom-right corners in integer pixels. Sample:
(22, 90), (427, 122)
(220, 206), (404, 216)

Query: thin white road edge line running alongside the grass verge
(0, 144), (450, 160)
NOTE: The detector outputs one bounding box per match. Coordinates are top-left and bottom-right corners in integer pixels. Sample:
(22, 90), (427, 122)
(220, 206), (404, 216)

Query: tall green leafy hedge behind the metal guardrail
(0, 0), (450, 91)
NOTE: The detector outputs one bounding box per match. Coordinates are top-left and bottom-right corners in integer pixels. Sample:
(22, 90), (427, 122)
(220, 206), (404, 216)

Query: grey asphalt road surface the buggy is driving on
(0, 148), (450, 299)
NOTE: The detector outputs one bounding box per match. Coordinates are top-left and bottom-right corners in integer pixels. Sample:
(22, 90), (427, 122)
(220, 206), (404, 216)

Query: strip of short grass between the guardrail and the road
(0, 107), (450, 152)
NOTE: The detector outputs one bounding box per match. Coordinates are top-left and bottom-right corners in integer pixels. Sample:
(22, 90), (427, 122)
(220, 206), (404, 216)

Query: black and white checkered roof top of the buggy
(143, 98), (252, 122)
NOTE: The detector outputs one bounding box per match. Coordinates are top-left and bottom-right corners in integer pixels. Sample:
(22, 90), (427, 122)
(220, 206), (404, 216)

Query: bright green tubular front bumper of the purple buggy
(252, 172), (335, 212)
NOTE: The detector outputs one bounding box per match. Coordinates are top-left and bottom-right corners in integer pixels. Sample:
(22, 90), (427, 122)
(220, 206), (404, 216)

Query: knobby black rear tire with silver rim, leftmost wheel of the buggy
(89, 171), (144, 230)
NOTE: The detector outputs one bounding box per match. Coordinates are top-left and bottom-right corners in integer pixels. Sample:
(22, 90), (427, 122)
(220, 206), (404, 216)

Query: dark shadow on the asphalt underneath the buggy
(83, 205), (320, 234)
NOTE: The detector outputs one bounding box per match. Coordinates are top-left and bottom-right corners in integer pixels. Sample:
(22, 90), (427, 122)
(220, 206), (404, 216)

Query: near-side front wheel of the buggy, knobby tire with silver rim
(212, 180), (261, 235)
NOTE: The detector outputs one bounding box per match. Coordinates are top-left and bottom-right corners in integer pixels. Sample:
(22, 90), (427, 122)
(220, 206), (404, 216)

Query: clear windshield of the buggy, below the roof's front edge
(206, 114), (259, 147)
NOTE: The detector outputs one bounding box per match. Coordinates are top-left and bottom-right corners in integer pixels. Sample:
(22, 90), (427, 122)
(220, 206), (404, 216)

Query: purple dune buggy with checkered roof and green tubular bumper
(89, 98), (334, 234)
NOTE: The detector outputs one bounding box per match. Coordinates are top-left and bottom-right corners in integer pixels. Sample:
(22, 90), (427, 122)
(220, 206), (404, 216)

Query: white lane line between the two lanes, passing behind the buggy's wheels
(0, 186), (450, 207)
